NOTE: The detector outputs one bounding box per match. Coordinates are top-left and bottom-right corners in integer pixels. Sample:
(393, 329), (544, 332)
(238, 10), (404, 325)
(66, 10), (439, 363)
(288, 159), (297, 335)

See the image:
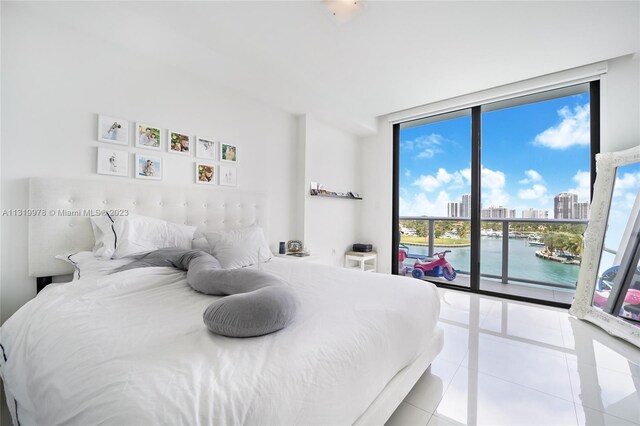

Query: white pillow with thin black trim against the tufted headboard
(91, 215), (196, 259)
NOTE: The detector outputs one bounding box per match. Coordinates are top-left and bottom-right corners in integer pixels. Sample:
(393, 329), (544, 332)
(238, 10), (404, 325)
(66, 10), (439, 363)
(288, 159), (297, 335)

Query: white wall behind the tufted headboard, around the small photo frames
(0, 3), (298, 321)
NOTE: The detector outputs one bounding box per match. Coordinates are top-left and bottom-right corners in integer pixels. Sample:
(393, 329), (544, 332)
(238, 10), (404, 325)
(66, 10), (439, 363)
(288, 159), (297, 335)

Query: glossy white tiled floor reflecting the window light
(387, 289), (640, 426)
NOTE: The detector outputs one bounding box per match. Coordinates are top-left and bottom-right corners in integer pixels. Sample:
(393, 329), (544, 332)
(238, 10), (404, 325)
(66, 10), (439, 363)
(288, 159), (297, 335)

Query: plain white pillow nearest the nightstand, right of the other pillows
(204, 226), (273, 269)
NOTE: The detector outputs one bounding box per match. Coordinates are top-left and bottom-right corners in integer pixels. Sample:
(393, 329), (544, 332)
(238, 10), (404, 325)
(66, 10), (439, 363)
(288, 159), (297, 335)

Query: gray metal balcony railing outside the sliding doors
(400, 216), (588, 290)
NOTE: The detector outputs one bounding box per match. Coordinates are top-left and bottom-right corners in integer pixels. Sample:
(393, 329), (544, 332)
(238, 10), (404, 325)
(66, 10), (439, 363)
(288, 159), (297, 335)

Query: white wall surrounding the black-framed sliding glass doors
(358, 53), (640, 272)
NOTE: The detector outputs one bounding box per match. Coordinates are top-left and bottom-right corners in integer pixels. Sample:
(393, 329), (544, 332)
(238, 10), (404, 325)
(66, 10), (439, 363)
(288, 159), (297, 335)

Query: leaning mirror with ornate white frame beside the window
(569, 146), (640, 347)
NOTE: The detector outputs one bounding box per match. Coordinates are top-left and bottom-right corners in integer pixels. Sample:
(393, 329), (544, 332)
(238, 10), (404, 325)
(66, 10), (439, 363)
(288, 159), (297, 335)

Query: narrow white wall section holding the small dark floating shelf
(299, 115), (360, 266)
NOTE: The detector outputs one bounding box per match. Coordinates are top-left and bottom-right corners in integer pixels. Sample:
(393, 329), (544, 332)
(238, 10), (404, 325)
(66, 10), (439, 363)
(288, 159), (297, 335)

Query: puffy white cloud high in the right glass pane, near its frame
(534, 103), (591, 149)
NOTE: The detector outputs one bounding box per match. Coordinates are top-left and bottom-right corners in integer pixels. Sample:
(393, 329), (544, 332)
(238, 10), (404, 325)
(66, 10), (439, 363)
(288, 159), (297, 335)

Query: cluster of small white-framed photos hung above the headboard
(96, 114), (238, 186)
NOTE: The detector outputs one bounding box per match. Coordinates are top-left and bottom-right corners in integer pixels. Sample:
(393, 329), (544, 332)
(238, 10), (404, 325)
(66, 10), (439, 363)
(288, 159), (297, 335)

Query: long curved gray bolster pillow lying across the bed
(117, 249), (298, 337)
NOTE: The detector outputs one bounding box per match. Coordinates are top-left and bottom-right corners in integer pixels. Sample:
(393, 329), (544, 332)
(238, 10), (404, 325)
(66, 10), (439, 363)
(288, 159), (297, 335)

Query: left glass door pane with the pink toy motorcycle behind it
(397, 110), (471, 287)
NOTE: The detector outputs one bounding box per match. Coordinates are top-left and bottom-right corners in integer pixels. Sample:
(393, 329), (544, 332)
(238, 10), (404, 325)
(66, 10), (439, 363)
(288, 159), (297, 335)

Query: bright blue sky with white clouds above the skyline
(400, 93), (600, 217)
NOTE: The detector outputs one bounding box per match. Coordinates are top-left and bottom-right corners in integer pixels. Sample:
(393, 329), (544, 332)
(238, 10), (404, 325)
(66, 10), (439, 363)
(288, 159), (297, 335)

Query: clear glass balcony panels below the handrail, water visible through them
(399, 217), (586, 304)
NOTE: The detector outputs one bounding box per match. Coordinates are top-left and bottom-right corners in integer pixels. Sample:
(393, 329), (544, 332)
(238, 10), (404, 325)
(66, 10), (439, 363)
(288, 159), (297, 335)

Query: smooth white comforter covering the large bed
(0, 259), (439, 425)
